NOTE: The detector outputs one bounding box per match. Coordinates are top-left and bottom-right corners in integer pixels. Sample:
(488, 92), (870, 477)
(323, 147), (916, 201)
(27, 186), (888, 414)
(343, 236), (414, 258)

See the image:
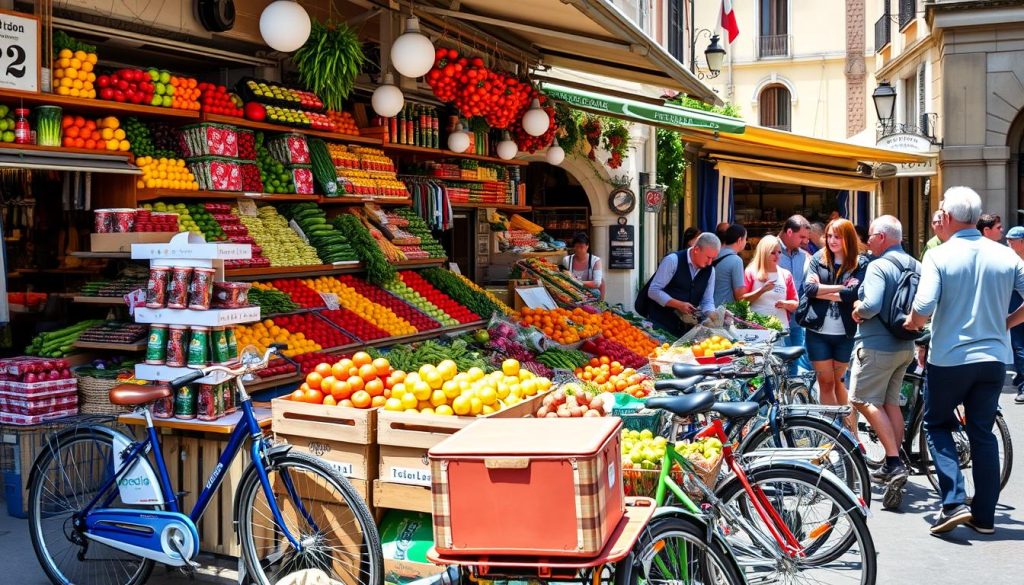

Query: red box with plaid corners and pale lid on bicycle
(429, 417), (626, 556)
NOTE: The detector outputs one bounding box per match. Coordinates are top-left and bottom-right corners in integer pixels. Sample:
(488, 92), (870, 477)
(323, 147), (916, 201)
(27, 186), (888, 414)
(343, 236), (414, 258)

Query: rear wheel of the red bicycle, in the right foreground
(718, 465), (878, 585)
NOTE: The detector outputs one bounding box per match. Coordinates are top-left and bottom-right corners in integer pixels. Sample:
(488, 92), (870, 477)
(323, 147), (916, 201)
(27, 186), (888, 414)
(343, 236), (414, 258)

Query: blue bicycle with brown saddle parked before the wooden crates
(29, 344), (383, 585)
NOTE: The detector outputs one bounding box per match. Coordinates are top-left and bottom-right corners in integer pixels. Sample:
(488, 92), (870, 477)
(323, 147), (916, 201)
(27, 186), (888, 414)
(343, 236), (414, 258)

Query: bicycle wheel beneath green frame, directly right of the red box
(615, 516), (744, 585)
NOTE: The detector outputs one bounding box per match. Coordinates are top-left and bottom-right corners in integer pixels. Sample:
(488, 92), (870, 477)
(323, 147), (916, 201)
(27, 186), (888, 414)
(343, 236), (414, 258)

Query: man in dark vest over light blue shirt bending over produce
(647, 233), (722, 337)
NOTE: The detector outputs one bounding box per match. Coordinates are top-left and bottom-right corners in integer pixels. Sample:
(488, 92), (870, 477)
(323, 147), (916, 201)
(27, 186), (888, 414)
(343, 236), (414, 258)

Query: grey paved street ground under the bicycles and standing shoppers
(6, 388), (1024, 585)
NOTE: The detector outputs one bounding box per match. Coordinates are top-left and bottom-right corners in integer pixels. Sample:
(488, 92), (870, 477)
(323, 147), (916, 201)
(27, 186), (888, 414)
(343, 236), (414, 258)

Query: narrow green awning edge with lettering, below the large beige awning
(542, 83), (746, 134)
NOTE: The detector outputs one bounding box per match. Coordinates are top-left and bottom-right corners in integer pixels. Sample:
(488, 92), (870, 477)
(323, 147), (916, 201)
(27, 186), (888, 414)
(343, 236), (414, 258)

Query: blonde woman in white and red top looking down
(739, 236), (799, 328)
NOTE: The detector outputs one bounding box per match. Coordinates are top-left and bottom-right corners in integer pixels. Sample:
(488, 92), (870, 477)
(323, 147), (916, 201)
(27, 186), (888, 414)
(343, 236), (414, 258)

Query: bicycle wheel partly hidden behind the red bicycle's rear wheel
(739, 415), (871, 506)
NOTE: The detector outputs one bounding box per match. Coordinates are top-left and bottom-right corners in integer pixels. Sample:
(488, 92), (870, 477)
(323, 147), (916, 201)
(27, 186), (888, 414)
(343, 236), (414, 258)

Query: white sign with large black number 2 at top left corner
(0, 10), (39, 92)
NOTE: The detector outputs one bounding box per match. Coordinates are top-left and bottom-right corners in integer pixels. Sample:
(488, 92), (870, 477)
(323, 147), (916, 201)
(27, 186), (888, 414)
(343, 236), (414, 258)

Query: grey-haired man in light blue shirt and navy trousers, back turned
(904, 186), (1024, 534)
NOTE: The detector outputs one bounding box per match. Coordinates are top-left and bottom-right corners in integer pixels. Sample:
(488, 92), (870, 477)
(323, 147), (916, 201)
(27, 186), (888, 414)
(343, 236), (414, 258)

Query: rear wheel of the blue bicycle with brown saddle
(29, 428), (155, 585)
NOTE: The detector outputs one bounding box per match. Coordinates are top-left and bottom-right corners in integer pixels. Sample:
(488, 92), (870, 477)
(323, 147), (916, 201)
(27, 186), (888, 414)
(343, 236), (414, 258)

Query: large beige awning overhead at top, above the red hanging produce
(416, 0), (722, 103)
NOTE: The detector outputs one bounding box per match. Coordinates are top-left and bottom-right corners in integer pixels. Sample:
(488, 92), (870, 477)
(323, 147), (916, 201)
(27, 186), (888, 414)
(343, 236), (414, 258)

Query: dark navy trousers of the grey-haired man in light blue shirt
(925, 362), (1006, 527)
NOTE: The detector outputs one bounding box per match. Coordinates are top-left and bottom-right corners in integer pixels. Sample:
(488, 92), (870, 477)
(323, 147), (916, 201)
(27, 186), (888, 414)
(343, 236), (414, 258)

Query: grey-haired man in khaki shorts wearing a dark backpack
(850, 215), (921, 508)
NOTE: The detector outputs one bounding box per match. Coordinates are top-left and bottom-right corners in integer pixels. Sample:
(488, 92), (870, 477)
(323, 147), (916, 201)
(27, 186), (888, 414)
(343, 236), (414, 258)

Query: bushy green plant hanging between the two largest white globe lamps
(292, 19), (366, 112)
